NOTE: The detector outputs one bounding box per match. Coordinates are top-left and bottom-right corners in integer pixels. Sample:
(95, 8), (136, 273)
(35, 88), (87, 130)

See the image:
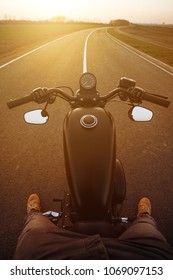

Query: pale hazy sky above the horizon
(0, 0), (173, 24)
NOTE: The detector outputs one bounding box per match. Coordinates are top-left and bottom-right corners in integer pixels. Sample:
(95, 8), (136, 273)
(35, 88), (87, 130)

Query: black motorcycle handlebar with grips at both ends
(7, 83), (170, 109)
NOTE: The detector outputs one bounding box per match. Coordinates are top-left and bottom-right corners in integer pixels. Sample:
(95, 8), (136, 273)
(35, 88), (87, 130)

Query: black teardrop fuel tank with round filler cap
(64, 107), (116, 219)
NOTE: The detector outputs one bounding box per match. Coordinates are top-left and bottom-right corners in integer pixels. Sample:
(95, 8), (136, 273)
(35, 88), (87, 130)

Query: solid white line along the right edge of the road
(106, 31), (173, 76)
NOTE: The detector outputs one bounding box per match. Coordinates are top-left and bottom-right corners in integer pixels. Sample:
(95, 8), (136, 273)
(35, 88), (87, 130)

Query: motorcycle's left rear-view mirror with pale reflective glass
(24, 109), (49, 124)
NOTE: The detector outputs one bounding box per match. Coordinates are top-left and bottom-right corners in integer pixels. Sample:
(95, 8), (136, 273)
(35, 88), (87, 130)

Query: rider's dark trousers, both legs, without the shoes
(14, 212), (173, 260)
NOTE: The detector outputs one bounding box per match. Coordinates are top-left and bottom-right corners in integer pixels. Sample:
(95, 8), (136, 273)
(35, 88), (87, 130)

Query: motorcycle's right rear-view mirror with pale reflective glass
(128, 106), (154, 122)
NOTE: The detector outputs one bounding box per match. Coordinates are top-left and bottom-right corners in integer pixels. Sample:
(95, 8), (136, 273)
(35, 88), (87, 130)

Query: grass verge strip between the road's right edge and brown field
(108, 27), (173, 66)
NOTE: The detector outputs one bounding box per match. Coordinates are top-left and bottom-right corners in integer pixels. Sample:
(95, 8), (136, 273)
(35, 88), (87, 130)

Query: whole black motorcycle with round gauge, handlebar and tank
(7, 72), (170, 236)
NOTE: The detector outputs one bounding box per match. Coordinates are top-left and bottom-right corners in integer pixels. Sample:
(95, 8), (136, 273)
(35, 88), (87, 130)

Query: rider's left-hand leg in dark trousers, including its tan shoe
(14, 195), (107, 260)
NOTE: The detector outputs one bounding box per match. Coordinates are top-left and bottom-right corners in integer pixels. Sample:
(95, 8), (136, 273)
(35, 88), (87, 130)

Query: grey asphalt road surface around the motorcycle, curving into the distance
(0, 27), (173, 259)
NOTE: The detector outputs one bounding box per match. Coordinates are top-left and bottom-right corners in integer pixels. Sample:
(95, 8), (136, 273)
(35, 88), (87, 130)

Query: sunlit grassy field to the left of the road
(0, 23), (104, 59)
